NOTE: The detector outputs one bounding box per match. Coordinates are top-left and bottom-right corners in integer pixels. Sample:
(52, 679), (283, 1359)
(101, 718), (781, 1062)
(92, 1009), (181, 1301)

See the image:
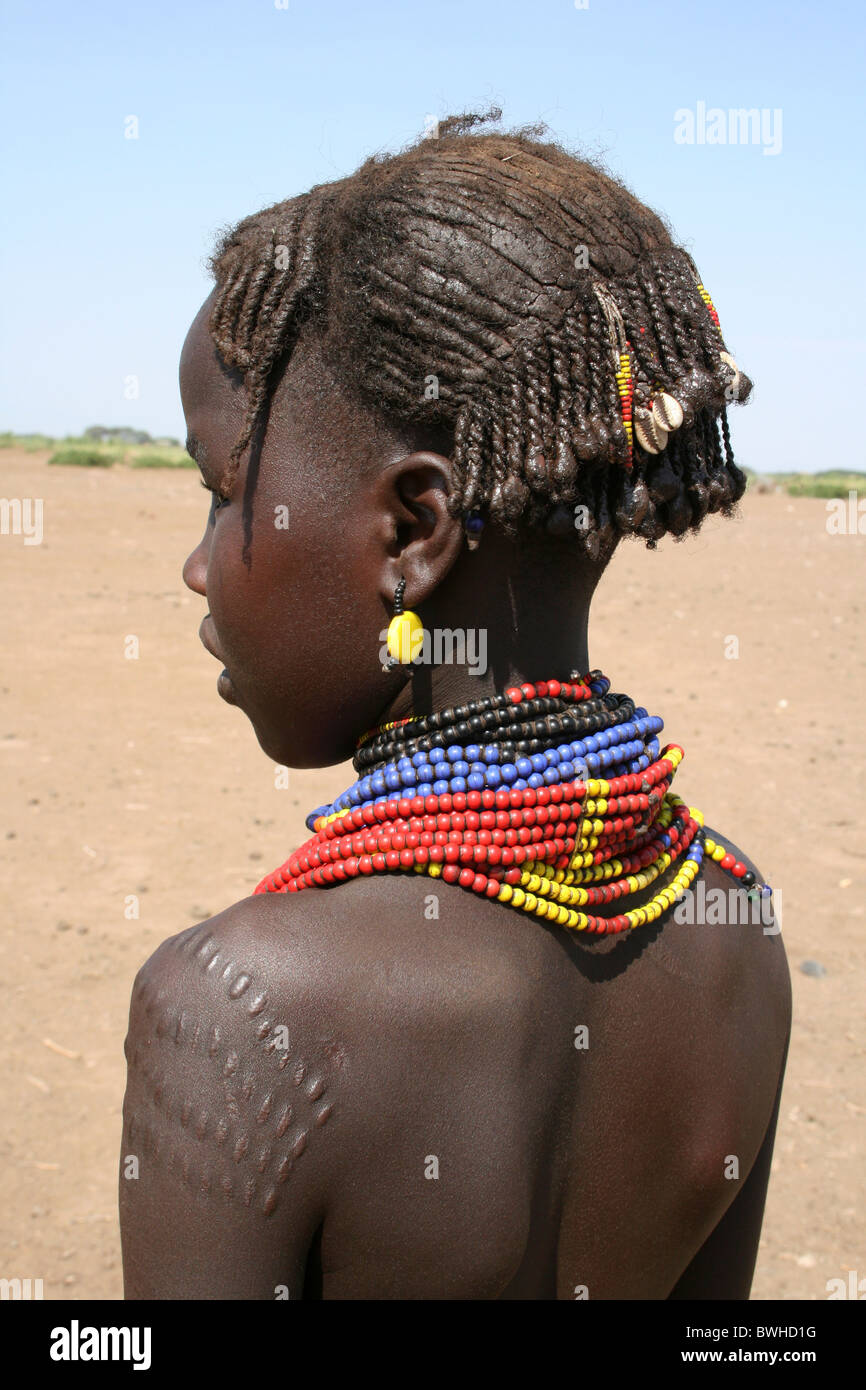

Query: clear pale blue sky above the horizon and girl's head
(0, 0), (866, 471)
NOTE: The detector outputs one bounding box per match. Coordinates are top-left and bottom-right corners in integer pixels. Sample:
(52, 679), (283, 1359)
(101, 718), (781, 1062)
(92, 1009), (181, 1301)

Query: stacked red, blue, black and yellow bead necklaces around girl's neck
(256, 671), (771, 934)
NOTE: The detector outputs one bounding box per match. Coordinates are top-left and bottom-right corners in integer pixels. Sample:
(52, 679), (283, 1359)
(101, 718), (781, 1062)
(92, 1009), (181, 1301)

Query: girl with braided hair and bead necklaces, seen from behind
(120, 117), (790, 1300)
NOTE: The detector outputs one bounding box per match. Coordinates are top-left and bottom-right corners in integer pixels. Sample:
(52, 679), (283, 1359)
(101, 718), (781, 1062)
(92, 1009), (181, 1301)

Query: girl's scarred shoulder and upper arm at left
(120, 894), (366, 1298)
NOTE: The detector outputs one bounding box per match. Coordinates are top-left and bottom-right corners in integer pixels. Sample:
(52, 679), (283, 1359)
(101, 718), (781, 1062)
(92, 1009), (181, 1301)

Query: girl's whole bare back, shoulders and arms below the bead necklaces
(121, 834), (790, 1300)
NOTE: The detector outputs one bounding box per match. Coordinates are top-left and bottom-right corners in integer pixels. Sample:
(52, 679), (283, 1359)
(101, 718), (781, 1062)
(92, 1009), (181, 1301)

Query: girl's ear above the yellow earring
(374, 450), (466, 609)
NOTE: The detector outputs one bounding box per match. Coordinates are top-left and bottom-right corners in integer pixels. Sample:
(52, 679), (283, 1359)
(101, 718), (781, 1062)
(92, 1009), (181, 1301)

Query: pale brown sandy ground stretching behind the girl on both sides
(0, 449), (866, 1300)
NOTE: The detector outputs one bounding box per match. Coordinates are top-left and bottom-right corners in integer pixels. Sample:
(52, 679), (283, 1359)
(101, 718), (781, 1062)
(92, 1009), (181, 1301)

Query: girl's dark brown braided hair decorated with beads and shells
(209, 110), (752, 557)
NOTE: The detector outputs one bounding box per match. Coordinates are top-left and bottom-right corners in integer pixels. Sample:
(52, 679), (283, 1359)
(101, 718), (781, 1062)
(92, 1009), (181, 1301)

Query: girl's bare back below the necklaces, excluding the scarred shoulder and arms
(304, 850), (790, 1298)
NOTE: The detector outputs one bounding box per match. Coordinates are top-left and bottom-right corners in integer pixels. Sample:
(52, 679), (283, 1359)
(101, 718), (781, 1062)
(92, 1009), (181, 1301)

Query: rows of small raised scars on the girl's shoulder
(124, 926), (346, 1216)
